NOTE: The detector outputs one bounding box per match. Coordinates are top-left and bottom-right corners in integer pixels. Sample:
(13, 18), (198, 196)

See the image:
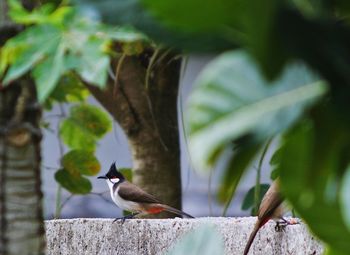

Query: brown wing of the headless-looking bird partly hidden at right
(258, 180), (283, 219)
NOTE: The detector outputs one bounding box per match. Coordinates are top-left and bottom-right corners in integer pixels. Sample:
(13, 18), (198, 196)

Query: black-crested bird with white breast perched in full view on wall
(97, 162), (194, 222)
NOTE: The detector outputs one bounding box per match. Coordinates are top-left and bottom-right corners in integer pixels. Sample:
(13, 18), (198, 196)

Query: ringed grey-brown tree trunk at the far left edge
(0, 11), (45, 255)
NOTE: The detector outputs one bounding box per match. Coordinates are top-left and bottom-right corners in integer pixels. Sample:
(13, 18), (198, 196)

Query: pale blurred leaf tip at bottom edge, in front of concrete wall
(167, 224), (225, 255)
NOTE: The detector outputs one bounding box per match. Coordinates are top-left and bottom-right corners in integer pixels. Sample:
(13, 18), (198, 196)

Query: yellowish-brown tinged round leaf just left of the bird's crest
(62, 150), (101, 175)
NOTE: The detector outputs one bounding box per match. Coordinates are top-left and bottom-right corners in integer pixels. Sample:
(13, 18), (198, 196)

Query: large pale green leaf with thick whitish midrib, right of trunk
(187, 51), (327, 171)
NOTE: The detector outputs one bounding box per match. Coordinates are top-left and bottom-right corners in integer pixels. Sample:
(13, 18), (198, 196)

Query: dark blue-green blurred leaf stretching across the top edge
(76, 0), (237, 52)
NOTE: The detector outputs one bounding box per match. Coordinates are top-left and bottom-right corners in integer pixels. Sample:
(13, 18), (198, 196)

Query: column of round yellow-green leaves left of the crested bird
(55, 103), (112, 194)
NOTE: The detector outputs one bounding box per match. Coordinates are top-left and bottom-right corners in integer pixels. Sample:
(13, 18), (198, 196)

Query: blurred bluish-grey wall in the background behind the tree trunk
(42, 56), (271, 219)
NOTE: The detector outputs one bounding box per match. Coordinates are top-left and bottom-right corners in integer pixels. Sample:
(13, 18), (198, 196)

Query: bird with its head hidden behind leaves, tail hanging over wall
(243, 179), (296, 255)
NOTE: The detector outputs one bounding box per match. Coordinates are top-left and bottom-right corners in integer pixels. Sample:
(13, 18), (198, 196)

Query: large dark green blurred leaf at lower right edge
(279, 104), (350, 254)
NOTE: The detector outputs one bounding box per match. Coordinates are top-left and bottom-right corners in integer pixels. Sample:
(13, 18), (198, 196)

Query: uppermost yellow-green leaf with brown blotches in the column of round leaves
(70, 104), (112, 138)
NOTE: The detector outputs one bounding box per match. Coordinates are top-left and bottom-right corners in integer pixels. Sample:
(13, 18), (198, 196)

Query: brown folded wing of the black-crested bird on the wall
(118, 181), (160, 203)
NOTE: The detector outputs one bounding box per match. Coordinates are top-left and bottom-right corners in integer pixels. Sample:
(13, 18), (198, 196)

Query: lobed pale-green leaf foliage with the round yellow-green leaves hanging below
(0, 0), (142, 194)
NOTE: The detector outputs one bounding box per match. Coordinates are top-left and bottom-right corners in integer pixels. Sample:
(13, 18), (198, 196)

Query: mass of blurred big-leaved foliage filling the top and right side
(78, 0), (350, 254)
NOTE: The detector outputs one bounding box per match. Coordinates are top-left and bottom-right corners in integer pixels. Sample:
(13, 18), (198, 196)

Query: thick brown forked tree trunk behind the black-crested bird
(88, 50), (181, 217)
